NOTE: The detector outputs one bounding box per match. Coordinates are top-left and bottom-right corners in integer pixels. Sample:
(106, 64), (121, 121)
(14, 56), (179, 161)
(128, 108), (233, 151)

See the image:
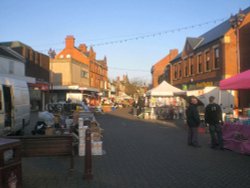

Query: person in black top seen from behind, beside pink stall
(205, 96), (223, 150)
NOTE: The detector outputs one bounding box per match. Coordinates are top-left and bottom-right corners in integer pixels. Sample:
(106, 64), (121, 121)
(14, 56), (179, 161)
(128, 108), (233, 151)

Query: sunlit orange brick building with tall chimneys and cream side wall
(50, 35), (108, 101)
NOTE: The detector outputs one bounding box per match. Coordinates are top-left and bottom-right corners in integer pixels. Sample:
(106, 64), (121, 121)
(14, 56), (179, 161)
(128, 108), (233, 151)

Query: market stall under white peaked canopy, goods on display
(145, 81), (186, 119)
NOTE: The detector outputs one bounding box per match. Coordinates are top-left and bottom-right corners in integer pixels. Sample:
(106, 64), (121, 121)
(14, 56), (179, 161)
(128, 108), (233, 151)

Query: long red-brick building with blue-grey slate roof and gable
(165, 7), (250, 107)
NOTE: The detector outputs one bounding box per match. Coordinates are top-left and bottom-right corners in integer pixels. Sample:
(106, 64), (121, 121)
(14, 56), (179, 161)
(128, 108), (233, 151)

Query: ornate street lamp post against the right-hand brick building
(229, 9), (245, 73)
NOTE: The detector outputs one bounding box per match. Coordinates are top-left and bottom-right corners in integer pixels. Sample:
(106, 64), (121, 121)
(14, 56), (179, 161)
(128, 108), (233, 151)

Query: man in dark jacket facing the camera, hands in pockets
(186, 96), (201, 147)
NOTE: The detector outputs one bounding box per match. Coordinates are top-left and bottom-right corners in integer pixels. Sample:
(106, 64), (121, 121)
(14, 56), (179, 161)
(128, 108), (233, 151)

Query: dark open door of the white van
(3, 85), (13, 127)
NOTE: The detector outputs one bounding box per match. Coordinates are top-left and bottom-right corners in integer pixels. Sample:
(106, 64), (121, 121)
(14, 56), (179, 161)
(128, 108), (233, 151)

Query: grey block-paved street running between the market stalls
(22, 109), (250, 188)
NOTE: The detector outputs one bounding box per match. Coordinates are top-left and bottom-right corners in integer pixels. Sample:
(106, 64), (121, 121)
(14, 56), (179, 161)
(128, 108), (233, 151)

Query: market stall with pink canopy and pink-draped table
(220, 70), (250, 155)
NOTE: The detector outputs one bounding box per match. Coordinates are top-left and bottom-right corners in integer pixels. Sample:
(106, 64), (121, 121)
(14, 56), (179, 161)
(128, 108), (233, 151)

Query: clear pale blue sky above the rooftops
(0, 0), (250, 82)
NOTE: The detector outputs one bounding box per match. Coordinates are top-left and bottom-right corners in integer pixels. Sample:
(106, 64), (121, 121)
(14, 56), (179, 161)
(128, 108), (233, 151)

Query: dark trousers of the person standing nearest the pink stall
(209, 124), (223, 148)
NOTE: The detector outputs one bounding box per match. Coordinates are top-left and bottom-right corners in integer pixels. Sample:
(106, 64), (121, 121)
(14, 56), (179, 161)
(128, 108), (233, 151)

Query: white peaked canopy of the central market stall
(146, 81), (186, 97)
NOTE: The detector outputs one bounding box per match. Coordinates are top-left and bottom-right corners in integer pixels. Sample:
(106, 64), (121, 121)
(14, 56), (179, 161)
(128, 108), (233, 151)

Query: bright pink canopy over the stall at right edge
(220, 70), (250, 90)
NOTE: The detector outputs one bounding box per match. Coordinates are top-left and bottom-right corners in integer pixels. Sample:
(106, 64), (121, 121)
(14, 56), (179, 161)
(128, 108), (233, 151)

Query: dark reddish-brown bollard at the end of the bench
(83, 128), (93, 180)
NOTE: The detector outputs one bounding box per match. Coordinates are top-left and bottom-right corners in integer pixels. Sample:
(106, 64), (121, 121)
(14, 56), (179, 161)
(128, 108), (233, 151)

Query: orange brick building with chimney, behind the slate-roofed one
(151, 49), (178, 88)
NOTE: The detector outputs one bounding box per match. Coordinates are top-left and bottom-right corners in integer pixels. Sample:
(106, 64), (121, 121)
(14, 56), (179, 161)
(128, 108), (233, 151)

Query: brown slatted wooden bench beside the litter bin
(8, 135), (74, 171)
